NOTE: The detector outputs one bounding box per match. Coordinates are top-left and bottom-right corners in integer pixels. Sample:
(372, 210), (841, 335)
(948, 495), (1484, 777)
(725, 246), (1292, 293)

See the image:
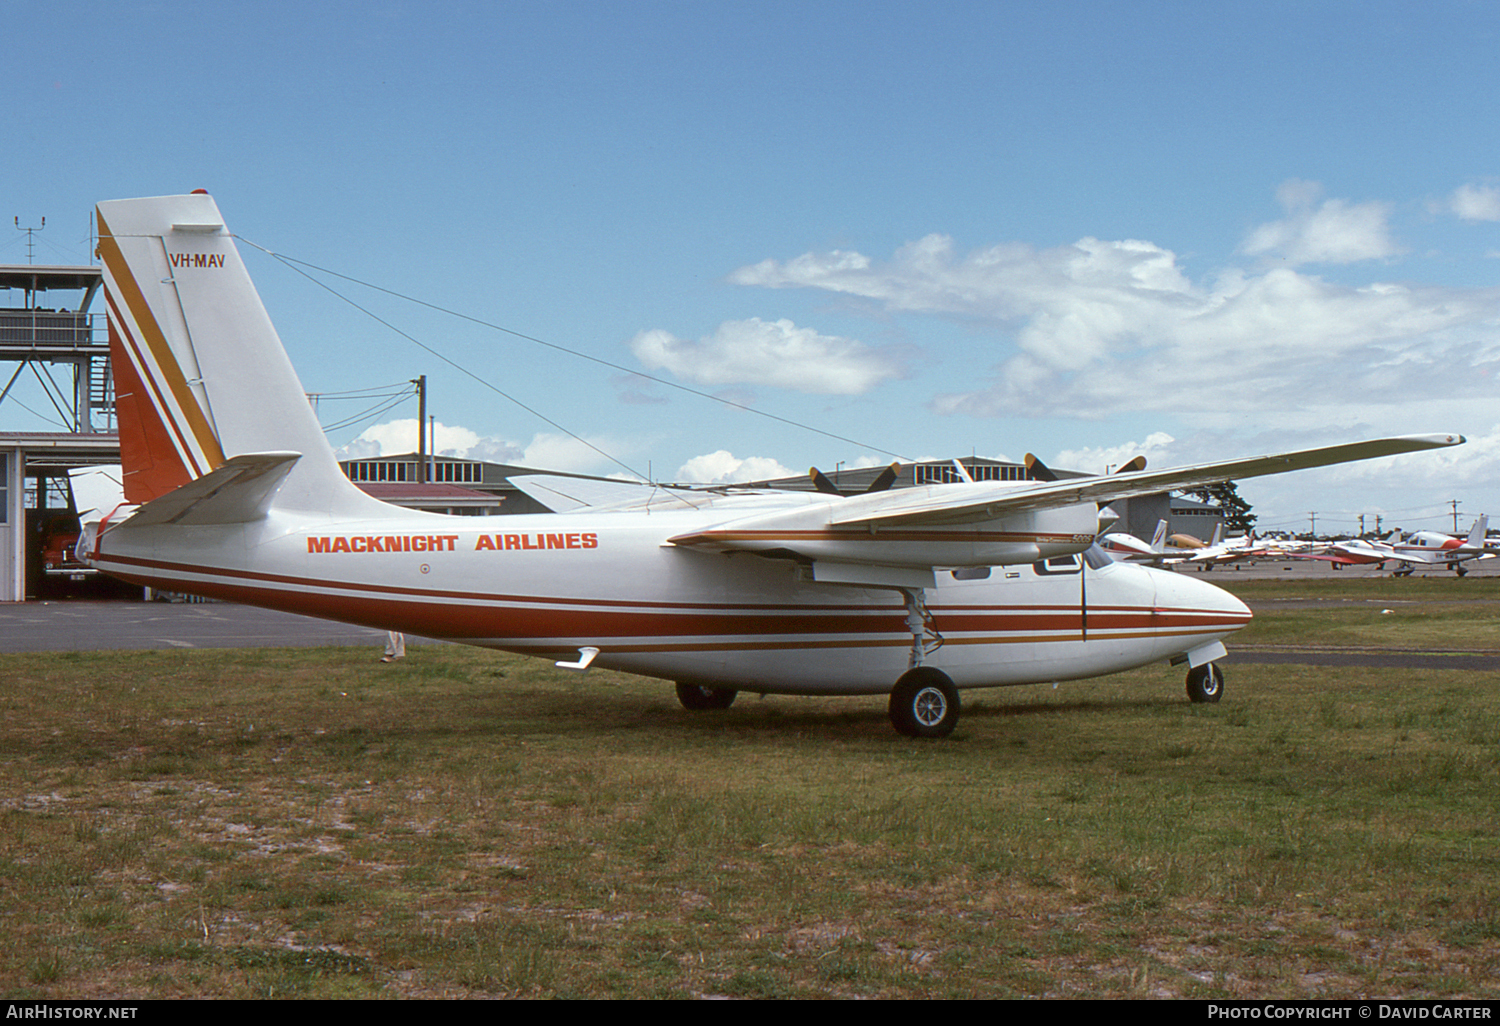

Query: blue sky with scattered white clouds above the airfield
(0, 0), (1500, 530)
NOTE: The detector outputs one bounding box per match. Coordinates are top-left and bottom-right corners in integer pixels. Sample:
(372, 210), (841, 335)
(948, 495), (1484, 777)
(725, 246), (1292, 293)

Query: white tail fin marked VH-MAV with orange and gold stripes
(99, 192), (381, 513)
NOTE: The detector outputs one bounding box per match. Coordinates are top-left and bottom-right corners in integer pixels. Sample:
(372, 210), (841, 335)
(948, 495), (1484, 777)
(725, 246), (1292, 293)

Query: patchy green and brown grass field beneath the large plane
(0, 575), (1500, 999)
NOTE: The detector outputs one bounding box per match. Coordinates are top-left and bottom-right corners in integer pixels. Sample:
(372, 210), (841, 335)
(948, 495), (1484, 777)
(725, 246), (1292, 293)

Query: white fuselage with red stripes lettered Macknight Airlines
(93, 510), (1250, 695)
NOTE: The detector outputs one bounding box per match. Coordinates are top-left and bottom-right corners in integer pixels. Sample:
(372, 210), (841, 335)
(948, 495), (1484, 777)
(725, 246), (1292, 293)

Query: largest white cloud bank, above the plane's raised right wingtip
(731, 182), (1500, 431)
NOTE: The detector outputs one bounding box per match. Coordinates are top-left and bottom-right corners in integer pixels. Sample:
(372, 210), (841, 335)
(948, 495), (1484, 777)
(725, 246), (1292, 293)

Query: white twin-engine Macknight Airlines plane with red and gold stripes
(78, 192), (1464, 737)
